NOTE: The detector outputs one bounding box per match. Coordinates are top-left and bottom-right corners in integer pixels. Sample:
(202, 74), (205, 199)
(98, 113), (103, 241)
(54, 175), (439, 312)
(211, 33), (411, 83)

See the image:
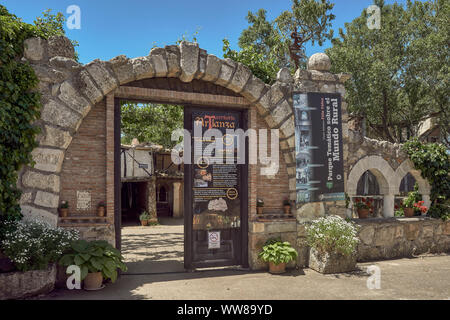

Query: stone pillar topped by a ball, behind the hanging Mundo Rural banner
(294, 53), (351, 222)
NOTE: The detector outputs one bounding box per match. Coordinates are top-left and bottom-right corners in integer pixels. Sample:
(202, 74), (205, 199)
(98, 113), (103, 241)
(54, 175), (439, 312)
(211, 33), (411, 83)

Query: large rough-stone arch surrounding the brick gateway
(18, 37), (295, 225)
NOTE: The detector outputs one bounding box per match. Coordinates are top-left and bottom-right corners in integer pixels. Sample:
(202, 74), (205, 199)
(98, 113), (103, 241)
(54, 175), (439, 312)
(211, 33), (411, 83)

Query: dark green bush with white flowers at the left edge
(0, 220), (79, 271)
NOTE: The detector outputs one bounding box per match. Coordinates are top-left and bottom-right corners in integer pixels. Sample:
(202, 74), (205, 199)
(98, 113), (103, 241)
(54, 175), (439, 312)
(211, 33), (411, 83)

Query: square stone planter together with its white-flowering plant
(306, 216), (359, 273)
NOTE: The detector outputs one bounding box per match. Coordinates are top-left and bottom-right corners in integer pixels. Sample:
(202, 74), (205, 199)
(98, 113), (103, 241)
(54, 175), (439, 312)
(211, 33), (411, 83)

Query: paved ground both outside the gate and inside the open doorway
(40, 223), (450, 300)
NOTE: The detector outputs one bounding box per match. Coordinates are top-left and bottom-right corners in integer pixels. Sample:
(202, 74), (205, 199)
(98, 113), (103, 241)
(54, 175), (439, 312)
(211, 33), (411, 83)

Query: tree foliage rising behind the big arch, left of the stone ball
(223, 0), (335, 84)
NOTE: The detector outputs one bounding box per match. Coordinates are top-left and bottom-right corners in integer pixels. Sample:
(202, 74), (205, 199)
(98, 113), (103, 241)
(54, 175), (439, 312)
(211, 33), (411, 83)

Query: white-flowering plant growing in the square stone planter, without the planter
(306, 216), (359, 256)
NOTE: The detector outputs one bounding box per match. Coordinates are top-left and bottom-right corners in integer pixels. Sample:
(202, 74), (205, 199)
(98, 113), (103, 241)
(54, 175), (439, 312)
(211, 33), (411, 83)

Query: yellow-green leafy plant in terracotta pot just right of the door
(259, 239), (298, 274)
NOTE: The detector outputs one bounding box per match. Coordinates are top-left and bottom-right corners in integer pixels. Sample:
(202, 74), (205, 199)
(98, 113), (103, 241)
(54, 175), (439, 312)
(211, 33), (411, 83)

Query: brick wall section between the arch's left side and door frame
(60, 100), (108, 215)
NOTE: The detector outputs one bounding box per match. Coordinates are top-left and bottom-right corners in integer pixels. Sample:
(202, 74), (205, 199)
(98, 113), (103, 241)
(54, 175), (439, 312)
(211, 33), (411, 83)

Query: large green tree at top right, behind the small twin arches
(326, 0), (450, 142)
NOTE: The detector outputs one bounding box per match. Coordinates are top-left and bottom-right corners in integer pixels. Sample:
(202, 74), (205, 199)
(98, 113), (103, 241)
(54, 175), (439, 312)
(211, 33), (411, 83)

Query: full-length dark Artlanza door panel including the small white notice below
(192, 110), (242, 264)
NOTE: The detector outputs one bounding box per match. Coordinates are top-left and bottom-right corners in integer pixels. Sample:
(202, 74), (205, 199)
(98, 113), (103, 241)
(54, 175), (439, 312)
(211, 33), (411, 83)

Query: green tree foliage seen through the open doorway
(121, 102), (183, 148)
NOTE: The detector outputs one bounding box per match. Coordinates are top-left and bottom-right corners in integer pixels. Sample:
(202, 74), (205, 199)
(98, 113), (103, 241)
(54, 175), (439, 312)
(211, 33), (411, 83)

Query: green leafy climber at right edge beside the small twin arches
(403, 139), (450, 220)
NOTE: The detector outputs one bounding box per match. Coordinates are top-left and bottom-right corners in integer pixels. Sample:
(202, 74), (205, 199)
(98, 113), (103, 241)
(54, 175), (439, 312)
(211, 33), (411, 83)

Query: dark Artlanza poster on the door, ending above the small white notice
(192, 111), (241, 230)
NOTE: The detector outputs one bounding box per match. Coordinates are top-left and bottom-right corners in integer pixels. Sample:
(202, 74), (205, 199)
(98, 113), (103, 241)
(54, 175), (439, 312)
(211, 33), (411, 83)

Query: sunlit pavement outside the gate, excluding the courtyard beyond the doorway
(41, 255), (450, 300)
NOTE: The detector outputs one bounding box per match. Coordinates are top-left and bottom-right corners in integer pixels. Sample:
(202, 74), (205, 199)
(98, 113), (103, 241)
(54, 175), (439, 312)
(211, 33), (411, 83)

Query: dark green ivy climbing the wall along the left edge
(0, 5), (72, 220)
